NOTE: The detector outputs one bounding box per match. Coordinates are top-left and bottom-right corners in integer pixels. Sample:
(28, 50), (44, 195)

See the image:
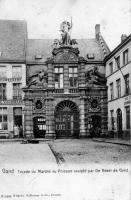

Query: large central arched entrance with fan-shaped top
(55, 100), (79, 138)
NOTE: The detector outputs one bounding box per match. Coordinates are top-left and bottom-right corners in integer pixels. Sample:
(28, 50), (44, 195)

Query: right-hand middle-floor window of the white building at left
(13, 83), (22, 99)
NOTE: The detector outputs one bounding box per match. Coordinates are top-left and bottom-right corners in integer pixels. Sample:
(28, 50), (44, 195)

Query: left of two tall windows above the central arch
(55, 67), (63, 88)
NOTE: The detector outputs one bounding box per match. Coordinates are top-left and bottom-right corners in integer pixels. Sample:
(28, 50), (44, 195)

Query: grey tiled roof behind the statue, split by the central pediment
(26, 39), (104, 62)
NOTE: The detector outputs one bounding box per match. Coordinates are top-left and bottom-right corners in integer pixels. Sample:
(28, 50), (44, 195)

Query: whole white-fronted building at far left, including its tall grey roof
(0, 20), (27, 138)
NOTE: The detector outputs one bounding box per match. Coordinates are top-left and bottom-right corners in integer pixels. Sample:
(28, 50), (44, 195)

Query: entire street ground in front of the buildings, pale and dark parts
(0, 139), (131, 165)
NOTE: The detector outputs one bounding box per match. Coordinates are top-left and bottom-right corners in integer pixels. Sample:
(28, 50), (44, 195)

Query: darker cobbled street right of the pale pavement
(50, 139), (131, 164)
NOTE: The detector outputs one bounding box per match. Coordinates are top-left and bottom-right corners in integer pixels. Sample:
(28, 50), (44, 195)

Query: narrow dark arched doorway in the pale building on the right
(116, 108), (122, 138)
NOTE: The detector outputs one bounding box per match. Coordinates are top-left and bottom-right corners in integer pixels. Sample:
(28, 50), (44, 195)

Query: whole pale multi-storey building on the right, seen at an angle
(105, 35), (131, 139)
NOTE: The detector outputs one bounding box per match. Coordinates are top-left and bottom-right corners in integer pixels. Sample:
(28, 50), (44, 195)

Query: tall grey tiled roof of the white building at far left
(0, 20), (27, 61)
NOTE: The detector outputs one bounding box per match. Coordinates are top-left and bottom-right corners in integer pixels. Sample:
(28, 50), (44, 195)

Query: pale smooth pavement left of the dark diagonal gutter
(0, 142), (56, 166)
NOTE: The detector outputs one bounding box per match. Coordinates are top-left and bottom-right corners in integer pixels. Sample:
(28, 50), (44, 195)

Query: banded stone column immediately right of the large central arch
(79, 97), (86, 138)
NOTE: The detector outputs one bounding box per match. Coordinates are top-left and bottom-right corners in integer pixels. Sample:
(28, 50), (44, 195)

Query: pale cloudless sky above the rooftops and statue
(0, 0), (131, 50)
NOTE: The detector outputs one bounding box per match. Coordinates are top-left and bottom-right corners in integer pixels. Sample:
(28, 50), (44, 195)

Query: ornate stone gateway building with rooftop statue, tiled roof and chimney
(23, 21), (110, 138)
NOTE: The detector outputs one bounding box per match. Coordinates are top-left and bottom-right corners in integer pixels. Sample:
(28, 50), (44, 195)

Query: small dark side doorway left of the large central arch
(33, 117), (46, 138)
